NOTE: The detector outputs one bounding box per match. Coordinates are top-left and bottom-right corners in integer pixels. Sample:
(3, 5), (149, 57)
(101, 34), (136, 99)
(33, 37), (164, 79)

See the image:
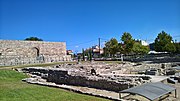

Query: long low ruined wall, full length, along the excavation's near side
(23, 67), (152, 92)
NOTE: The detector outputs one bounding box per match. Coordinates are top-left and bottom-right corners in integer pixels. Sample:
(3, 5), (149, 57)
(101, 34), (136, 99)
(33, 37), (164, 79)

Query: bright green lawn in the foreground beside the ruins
(0, 70), (107, 101)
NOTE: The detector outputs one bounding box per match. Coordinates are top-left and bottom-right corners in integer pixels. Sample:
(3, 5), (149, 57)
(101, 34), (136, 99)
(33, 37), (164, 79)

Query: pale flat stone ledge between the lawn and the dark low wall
(22, 78), (121, 101)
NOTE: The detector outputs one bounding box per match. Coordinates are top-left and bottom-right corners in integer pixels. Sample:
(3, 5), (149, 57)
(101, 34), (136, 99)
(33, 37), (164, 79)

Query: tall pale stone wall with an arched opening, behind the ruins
(0, 40), (71, 66)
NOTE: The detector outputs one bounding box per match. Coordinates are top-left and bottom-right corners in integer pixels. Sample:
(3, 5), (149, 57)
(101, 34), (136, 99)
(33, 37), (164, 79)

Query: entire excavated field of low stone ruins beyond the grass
(17, 61), (179, 100)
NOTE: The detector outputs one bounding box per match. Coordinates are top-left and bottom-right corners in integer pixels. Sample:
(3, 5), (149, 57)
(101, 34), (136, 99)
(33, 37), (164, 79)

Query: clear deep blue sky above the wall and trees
(0, 0), (180, 52)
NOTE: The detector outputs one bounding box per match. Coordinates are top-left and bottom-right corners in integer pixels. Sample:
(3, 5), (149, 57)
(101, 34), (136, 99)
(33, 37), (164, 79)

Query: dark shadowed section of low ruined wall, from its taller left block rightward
(47, 70), (130, 92)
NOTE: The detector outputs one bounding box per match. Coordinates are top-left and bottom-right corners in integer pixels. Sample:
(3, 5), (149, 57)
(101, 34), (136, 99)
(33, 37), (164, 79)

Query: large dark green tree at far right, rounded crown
(154, 31), (176, 52)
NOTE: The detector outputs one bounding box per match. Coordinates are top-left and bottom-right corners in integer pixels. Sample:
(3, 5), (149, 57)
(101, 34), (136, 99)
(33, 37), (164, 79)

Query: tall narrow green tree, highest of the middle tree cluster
(121, 32), (135, 54)
